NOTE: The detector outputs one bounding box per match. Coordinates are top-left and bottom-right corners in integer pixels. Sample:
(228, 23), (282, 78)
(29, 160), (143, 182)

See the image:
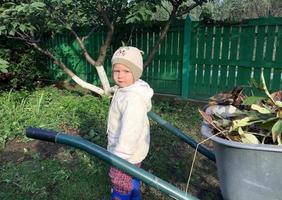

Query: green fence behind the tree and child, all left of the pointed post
(49, 20), (184, 95)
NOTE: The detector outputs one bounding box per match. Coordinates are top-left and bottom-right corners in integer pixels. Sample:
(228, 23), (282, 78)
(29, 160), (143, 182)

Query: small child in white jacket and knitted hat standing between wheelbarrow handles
(107, 47), (153, 200)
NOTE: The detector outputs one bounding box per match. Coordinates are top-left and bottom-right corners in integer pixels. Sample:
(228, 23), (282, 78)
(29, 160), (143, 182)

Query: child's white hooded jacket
(107, 79), (153, 164)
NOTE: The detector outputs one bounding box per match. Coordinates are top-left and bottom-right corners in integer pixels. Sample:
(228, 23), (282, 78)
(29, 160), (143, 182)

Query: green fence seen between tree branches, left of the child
(47, 31), (106, 84)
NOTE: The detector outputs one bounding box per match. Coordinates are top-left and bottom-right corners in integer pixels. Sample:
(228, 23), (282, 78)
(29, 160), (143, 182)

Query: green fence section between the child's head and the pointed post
(123, 21), (184, 95)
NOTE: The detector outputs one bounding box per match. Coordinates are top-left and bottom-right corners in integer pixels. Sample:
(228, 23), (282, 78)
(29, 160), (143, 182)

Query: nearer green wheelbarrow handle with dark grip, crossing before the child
(26, 127), (197, 200)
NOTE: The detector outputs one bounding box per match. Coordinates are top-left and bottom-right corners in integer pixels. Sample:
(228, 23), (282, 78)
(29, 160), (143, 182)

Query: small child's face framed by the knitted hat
(113, 63), (134, 88)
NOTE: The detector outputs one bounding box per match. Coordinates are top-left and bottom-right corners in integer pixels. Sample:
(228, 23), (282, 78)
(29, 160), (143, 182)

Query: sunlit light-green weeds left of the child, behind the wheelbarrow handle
(0, 87), (108, 148)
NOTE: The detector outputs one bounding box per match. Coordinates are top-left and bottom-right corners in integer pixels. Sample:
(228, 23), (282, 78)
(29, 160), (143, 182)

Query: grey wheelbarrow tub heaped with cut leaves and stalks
(199, 74), (282, 200)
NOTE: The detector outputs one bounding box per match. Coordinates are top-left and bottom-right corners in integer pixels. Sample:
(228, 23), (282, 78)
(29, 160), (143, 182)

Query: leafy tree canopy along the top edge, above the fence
(0, 0), (212, 34)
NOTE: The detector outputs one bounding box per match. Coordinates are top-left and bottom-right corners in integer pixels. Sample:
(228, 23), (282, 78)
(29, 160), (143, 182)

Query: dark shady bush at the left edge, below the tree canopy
(0, 39), (49, 91)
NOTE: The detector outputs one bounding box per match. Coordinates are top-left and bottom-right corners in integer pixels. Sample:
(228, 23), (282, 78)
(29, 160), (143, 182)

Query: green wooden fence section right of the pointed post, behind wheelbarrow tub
(182, 18), (282, 99)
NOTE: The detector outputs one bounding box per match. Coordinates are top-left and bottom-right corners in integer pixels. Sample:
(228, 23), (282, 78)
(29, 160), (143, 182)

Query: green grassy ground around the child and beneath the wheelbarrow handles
(0, 86), (221, 200)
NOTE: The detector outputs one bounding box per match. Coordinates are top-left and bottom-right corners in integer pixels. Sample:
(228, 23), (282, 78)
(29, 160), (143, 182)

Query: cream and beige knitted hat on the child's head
(112, 46), (143, 81)
